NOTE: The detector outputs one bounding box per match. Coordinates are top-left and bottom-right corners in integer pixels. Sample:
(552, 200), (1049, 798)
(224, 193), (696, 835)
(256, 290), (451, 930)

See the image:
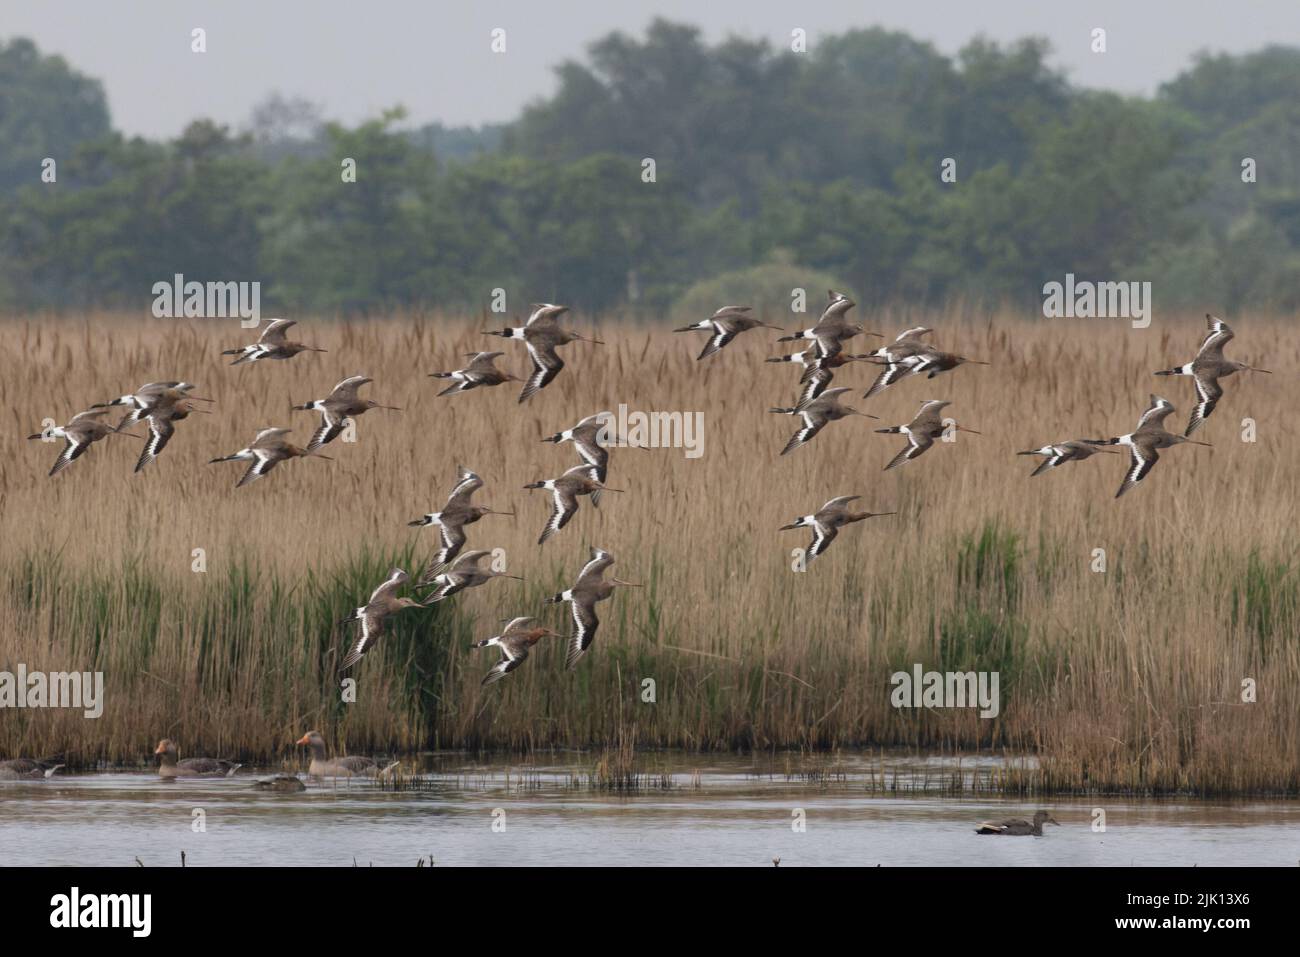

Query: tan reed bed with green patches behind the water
(0, 307), (1300, 793)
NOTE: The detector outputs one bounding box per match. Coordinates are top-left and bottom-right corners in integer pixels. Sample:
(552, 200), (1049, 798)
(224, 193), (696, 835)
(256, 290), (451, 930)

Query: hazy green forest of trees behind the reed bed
(0, 21), (1300, 316)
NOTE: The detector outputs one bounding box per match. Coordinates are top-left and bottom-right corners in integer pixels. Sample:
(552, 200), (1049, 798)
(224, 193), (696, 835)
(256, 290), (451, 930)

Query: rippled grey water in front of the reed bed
(0, 754), (1300, 867)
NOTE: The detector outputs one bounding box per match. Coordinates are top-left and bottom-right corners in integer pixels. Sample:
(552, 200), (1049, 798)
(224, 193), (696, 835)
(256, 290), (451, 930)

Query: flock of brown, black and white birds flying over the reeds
(30, 297), (1268, 684)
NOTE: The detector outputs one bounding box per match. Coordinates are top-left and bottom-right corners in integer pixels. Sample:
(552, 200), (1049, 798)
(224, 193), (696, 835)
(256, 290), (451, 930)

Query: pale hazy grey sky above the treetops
(10, 0), (1300, 137)
